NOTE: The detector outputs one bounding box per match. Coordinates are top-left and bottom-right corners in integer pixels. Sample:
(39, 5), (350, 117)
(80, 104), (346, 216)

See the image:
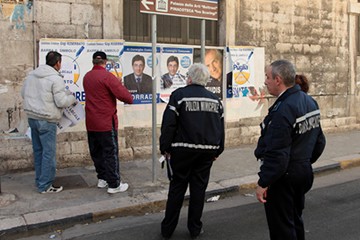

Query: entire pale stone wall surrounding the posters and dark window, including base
(0, 0), (360, 171)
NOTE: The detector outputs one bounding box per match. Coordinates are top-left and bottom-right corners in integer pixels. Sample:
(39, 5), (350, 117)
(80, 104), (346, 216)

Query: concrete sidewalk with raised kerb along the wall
(0, 130), (360, 239)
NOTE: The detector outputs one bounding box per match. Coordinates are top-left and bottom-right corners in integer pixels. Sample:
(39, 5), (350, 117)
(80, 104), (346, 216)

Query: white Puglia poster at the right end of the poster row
(226, 47), (266, 120)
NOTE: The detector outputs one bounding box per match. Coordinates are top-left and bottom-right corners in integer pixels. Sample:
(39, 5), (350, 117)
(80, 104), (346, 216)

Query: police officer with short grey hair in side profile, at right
(255, 60), (325, 240)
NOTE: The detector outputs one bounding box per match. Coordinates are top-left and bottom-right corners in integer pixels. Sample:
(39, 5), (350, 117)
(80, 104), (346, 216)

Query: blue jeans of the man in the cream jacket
(28, 118), (57, 192)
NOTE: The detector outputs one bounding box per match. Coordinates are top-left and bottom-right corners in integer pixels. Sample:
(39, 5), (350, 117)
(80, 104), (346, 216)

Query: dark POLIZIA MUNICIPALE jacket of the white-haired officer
(160, 84), (225, 156)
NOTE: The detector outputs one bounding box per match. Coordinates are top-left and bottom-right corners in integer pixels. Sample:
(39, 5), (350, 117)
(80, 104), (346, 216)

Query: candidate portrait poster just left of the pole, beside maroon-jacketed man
(121, 43), (160, 104)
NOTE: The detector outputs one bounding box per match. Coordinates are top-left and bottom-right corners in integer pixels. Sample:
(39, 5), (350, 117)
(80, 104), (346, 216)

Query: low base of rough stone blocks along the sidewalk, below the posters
(0, 117), (360, 175)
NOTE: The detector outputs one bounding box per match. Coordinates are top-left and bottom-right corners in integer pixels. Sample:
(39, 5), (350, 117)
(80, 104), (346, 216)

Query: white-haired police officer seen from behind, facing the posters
(160, 63), (225, 239)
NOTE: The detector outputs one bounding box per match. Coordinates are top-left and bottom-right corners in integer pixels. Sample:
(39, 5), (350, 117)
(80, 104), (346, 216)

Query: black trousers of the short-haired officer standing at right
(265, 162), (314, 240)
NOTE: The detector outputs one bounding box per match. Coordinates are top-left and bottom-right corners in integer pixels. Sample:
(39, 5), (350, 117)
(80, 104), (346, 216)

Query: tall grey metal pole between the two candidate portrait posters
(151, 14), (157, 183)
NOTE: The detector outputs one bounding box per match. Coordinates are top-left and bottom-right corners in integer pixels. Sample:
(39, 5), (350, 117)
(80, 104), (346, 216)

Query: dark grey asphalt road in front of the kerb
(19, 167), (360, 240)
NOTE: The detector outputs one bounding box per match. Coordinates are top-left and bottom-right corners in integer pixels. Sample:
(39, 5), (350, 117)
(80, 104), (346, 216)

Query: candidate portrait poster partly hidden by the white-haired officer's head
(158, 47), (193, 103)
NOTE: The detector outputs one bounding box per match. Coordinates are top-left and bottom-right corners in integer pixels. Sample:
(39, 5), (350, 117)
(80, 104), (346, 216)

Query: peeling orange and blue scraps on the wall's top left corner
(0, 0), (33, 30)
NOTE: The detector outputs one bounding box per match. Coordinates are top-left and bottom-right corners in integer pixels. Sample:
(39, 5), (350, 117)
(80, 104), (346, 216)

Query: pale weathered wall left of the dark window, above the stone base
(0, 0), (105, 132)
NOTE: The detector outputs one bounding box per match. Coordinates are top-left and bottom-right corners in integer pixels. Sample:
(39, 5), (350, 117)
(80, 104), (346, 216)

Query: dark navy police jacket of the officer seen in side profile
(255, 85), (326, 187)
